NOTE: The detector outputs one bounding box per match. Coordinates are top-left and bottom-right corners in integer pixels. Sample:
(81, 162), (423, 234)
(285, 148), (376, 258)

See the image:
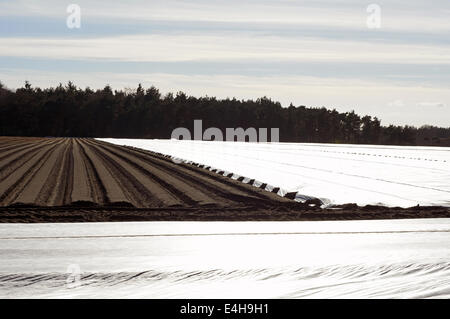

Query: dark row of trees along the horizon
(0, 82), (450, 146)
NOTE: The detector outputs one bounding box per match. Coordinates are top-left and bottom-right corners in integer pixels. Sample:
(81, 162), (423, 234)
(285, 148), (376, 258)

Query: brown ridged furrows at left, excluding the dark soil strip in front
(0, 138), (289, 208)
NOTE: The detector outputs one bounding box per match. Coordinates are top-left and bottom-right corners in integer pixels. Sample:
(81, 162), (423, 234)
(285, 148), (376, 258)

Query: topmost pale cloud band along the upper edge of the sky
(0, 0), (450, 33)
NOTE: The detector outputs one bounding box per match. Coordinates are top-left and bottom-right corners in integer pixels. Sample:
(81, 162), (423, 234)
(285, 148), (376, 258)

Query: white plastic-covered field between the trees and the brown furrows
(100, 138), (450, 207)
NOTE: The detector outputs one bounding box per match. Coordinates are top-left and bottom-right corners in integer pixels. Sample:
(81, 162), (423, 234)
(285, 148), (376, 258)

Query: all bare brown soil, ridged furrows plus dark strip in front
(0, 137), (450, 222)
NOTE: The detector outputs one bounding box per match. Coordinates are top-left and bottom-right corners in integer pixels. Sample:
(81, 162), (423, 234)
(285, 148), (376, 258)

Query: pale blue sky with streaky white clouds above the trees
(0, 0), (450, 127)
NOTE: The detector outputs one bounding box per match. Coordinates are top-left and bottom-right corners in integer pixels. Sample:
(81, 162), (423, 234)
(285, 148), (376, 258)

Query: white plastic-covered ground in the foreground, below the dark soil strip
(0, 219), (450, 299)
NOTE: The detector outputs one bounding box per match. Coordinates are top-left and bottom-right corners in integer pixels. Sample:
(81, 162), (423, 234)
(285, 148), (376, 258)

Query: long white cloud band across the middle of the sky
(0, 35), (450, 64)
